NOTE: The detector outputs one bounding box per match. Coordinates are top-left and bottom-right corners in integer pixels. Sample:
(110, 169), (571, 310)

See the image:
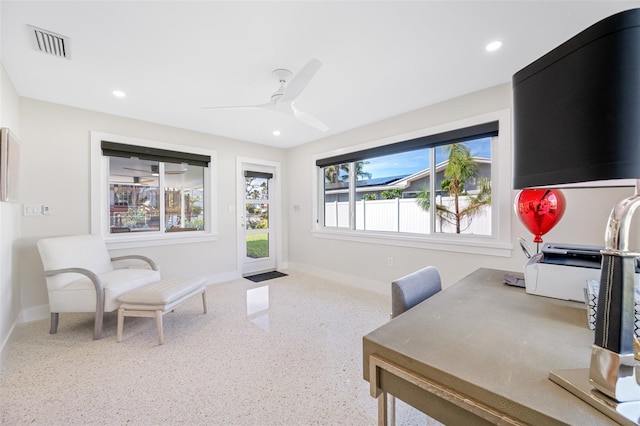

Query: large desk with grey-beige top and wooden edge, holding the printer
(363, 268), (615, 426)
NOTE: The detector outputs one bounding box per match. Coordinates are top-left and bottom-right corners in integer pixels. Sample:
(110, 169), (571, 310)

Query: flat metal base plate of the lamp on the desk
(549, 368), (640, 425)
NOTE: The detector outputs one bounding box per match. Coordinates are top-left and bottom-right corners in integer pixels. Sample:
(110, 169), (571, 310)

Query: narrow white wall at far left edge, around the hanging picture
(0, 64), (20, 350)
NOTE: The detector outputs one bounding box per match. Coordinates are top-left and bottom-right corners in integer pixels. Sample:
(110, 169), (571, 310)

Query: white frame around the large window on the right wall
(312, 109), (513, 257)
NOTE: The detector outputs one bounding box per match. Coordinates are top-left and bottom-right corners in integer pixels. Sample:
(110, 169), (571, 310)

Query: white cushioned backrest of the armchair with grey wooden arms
(37, 235), (113, 289)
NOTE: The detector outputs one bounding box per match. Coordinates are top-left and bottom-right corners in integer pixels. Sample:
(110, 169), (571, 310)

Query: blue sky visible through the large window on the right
(363, 138), (491, 179)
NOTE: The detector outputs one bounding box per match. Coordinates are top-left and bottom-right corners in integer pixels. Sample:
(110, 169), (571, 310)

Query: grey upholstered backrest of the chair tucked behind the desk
(391, 266), (442, 318)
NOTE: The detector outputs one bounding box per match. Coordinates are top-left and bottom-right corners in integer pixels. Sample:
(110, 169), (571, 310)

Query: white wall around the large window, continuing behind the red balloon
(287, 84), (633, 293)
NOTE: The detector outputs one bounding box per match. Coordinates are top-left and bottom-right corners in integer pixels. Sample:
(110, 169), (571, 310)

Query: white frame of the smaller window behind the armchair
(91, 132), (218, 249)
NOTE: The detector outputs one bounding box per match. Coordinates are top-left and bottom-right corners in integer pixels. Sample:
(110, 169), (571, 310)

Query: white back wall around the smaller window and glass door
(17, 98), (287, 320)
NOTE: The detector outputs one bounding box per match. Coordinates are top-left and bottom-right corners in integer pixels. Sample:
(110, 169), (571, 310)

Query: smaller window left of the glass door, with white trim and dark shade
(92, 133), (215, 243)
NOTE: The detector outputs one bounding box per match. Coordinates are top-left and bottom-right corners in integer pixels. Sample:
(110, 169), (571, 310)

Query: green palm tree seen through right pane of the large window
(416, 143), (491, 234)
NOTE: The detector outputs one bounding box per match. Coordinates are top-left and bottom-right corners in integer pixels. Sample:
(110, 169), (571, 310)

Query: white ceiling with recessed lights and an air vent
(0, 0), (640, 148)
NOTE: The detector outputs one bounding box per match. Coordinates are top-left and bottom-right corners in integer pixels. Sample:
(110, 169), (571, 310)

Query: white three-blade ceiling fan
(204, 59), (329, 132)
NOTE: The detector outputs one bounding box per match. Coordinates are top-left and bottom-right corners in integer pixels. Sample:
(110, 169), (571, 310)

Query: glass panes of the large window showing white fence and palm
(322, 137), (491, 235)
